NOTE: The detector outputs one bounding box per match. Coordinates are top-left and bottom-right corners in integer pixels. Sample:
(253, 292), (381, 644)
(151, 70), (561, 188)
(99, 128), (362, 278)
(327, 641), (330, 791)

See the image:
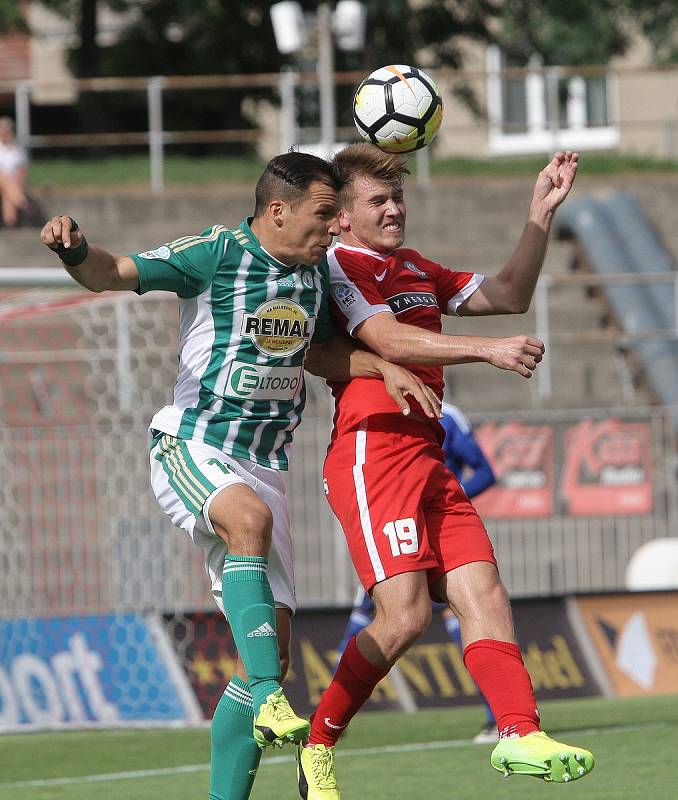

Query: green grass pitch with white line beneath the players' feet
(0, 696), (678, 800)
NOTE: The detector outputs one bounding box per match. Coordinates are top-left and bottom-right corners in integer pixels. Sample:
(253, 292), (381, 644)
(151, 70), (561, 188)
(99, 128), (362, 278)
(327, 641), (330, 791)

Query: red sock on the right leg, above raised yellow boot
(464, 639), (539, 738)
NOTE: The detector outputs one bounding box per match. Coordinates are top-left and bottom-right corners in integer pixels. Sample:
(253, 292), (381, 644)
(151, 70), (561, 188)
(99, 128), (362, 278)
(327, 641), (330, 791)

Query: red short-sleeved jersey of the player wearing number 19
(328, 243), (484, 436)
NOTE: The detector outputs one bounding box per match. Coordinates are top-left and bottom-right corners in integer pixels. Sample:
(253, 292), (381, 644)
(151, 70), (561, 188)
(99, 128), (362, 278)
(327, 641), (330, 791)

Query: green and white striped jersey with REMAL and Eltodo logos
(132, 220), (332, 470)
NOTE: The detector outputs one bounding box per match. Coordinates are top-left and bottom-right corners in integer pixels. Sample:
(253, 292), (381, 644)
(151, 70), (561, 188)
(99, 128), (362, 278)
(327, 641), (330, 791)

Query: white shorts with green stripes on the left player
(150, 433), (297, 613)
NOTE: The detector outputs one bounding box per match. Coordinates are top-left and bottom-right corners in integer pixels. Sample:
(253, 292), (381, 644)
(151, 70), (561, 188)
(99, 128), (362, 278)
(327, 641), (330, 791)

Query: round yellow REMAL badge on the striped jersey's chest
(240, 297), (315, 358)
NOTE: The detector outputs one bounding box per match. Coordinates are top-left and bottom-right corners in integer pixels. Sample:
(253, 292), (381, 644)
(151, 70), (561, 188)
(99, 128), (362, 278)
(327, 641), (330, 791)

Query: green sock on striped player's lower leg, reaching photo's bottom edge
(210, 675), (261, 800)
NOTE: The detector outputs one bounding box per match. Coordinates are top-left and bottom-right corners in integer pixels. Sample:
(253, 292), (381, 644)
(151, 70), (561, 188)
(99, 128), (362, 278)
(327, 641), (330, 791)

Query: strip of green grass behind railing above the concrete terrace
(30, 153), (678, 189)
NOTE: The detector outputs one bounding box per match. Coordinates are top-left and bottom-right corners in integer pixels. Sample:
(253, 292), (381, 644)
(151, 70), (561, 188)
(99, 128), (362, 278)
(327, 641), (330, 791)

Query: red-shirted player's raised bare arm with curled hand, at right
(458, 151), (579, 315)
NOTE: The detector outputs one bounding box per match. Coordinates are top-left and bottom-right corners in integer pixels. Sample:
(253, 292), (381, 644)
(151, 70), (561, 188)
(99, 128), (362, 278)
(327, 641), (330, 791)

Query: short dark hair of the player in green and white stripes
(254, 151), (340, 217)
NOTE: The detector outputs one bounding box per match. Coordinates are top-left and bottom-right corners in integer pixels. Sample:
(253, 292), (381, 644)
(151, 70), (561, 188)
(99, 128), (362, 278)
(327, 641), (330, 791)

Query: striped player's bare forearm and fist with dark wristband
(40, 214), (139, 292)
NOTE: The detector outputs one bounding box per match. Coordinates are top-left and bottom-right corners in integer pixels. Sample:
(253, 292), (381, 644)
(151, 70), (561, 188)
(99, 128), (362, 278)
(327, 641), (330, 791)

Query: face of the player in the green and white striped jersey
(281, 181), (339, 266)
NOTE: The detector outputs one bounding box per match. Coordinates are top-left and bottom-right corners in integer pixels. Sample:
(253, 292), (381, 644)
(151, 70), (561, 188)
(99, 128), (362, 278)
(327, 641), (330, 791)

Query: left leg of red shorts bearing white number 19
(324, 430), (436, 590)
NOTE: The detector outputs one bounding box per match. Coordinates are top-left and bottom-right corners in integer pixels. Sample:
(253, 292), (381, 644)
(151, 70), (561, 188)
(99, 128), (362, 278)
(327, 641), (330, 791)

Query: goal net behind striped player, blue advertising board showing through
(0, 288), (354, 729)
